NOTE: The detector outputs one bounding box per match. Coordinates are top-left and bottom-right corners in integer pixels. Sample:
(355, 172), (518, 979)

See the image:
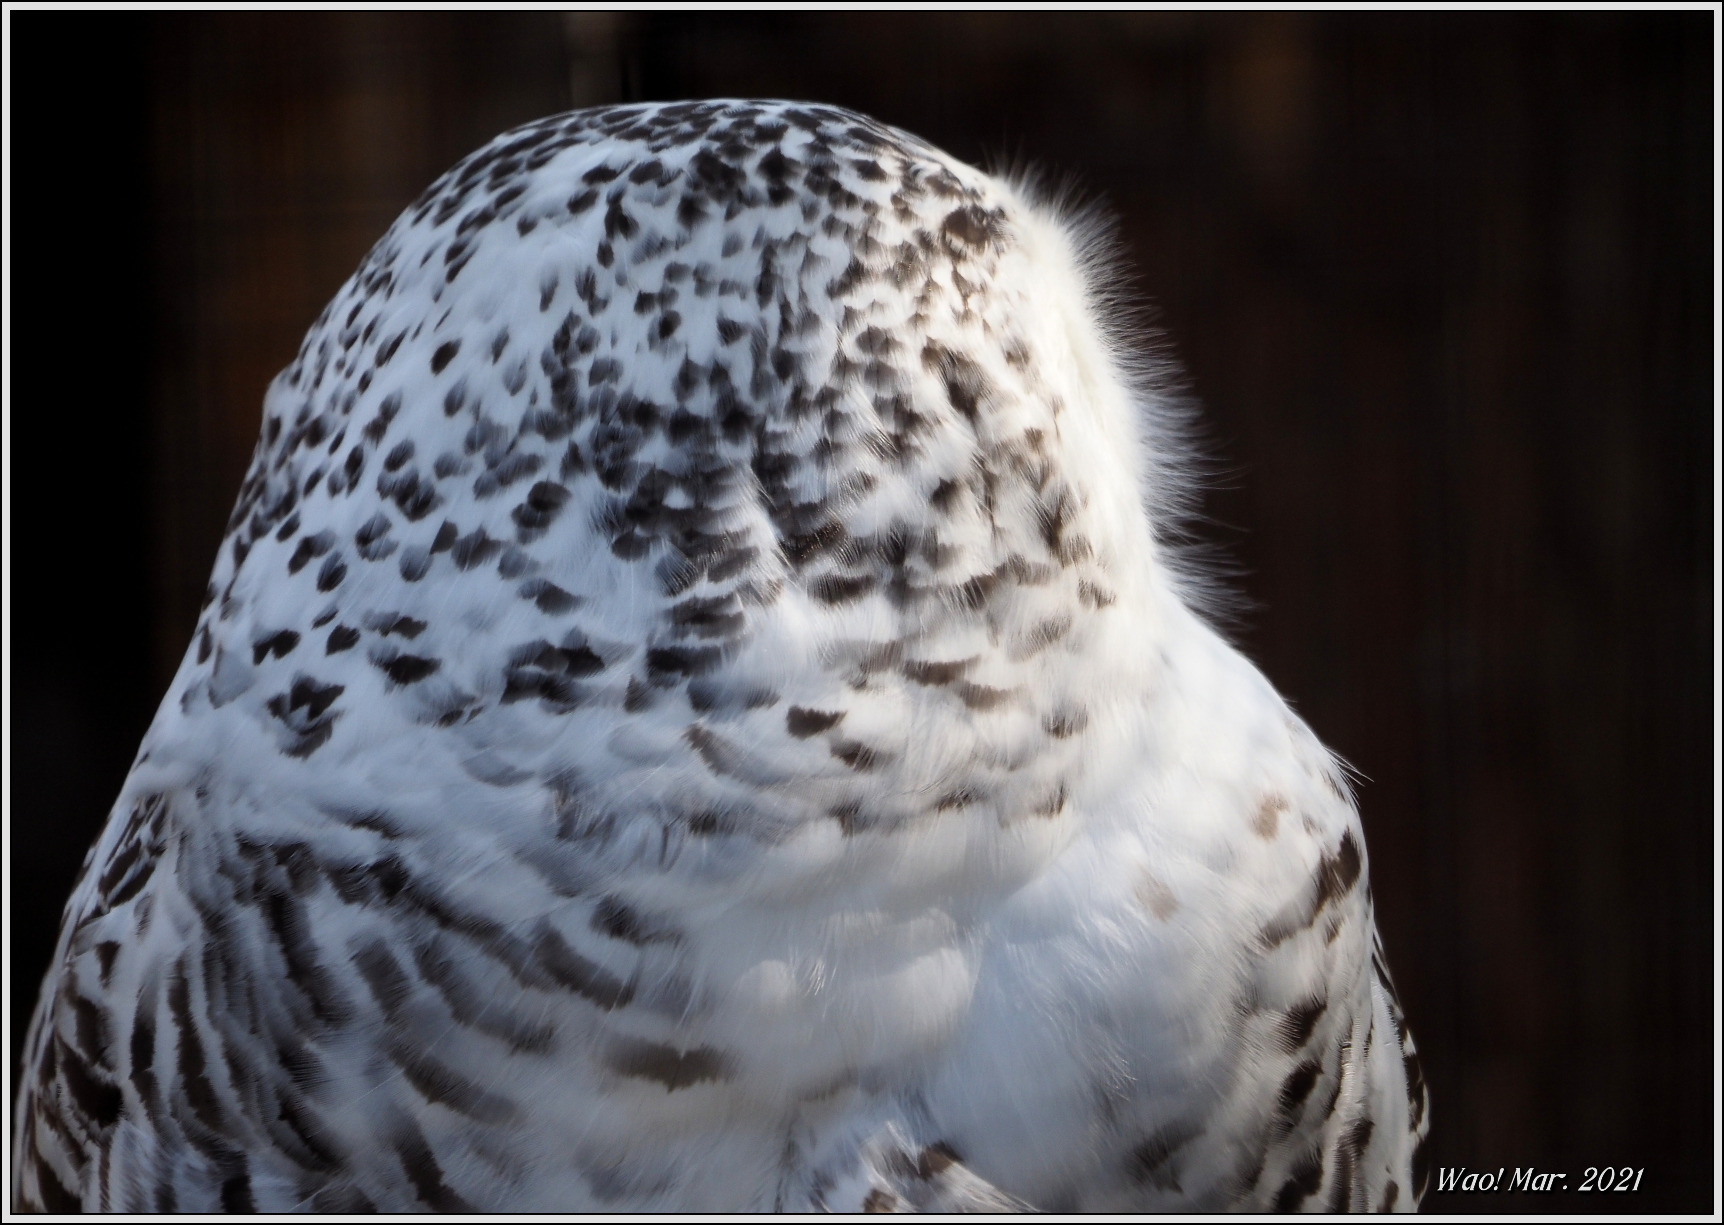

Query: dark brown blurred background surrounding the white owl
(7, 12), (1717, 1213)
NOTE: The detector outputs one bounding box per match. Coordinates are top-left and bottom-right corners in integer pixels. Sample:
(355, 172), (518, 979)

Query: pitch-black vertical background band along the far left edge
(5, 16), (156, 1081)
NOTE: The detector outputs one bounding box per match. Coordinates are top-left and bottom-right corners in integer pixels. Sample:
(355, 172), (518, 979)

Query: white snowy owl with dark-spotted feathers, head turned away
(14, 102), (1427, 1213)
